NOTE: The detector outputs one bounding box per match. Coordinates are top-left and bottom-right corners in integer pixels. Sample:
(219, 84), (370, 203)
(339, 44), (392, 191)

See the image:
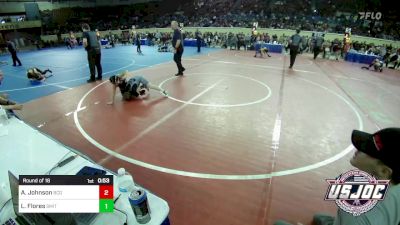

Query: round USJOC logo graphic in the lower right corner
(325, 170), (389, 216)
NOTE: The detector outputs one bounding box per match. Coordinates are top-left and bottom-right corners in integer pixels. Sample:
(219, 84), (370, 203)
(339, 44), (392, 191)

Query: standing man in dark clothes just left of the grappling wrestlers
(82, 23), (103, 83)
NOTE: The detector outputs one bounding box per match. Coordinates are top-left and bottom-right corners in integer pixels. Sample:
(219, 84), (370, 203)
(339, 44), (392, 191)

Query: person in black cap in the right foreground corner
(274, 128), (400, 225)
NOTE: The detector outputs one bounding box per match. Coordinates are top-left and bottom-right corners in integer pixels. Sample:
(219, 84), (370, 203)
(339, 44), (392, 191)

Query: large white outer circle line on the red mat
(74, 78), (364, 180)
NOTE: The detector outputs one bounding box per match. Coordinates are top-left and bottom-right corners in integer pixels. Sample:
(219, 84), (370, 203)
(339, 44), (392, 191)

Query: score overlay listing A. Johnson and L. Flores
(18, 175), (114, 213)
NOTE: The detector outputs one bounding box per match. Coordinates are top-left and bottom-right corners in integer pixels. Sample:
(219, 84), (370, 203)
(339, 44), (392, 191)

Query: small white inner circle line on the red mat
(158, 73), (272, 108)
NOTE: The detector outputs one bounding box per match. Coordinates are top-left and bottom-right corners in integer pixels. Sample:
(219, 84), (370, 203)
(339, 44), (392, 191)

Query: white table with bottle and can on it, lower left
(0, 118), (169, 225)
